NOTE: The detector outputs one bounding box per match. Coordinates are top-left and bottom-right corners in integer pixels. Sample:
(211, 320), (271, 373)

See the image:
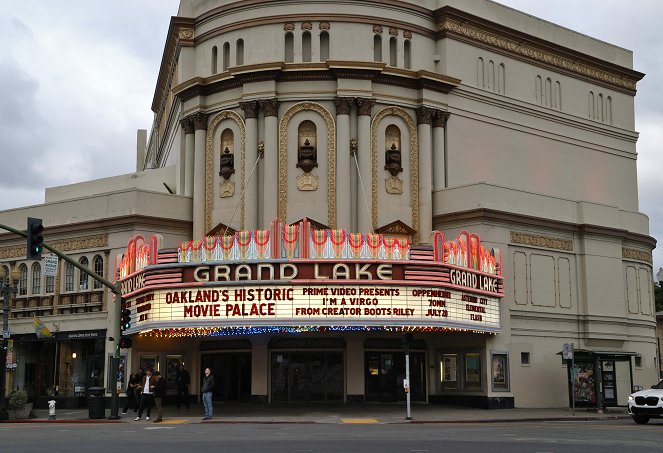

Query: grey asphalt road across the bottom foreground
(0, 419), (663, 453)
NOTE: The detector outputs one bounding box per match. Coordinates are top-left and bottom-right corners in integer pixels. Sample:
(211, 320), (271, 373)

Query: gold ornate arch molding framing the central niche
(278, 101), (336, 228)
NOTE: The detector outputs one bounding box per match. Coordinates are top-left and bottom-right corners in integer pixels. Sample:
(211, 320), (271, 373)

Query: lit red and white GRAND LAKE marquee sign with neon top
(119, 220), (503, 334)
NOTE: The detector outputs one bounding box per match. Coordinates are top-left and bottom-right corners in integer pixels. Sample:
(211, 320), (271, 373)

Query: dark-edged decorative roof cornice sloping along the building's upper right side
(436, 7), (644, 94)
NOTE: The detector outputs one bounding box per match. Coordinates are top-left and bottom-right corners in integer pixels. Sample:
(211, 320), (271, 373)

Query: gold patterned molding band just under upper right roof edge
(437, 17), (636, 91)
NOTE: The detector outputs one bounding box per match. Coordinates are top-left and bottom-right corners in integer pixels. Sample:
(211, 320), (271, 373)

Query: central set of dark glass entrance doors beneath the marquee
(271, 351), (344, 402)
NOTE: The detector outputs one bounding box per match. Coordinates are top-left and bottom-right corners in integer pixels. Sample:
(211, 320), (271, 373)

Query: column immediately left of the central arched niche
(260, 99), (279, 228)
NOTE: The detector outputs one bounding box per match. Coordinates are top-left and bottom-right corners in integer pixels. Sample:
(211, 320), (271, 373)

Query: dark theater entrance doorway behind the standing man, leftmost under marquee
(200, 352), (251, 402)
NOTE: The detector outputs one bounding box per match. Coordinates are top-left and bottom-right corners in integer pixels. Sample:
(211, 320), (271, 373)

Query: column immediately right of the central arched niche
(330, 97), (354, 232)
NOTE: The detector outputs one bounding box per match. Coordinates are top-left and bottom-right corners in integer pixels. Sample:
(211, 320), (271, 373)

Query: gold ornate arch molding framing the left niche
(205, 110), (246, 232)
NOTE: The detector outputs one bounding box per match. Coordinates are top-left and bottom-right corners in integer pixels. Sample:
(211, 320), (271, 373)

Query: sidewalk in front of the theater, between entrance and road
(1, 403), (628, 424)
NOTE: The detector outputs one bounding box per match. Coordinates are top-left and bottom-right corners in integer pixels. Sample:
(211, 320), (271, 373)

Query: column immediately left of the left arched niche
(192, 112), (207, 240)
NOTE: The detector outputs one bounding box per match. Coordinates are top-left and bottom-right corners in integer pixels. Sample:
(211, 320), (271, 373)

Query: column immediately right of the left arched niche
(239, 101), (258, 230)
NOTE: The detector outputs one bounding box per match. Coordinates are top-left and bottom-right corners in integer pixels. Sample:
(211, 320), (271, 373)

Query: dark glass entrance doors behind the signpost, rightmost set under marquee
(365, 351), (426, 403)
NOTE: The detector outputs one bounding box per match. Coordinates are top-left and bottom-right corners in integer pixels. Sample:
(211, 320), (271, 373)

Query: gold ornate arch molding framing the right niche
(371, 107), (419, 243)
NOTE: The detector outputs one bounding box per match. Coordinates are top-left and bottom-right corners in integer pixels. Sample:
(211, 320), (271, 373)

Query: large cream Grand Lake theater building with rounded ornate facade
(0, 0), (658, 408)
